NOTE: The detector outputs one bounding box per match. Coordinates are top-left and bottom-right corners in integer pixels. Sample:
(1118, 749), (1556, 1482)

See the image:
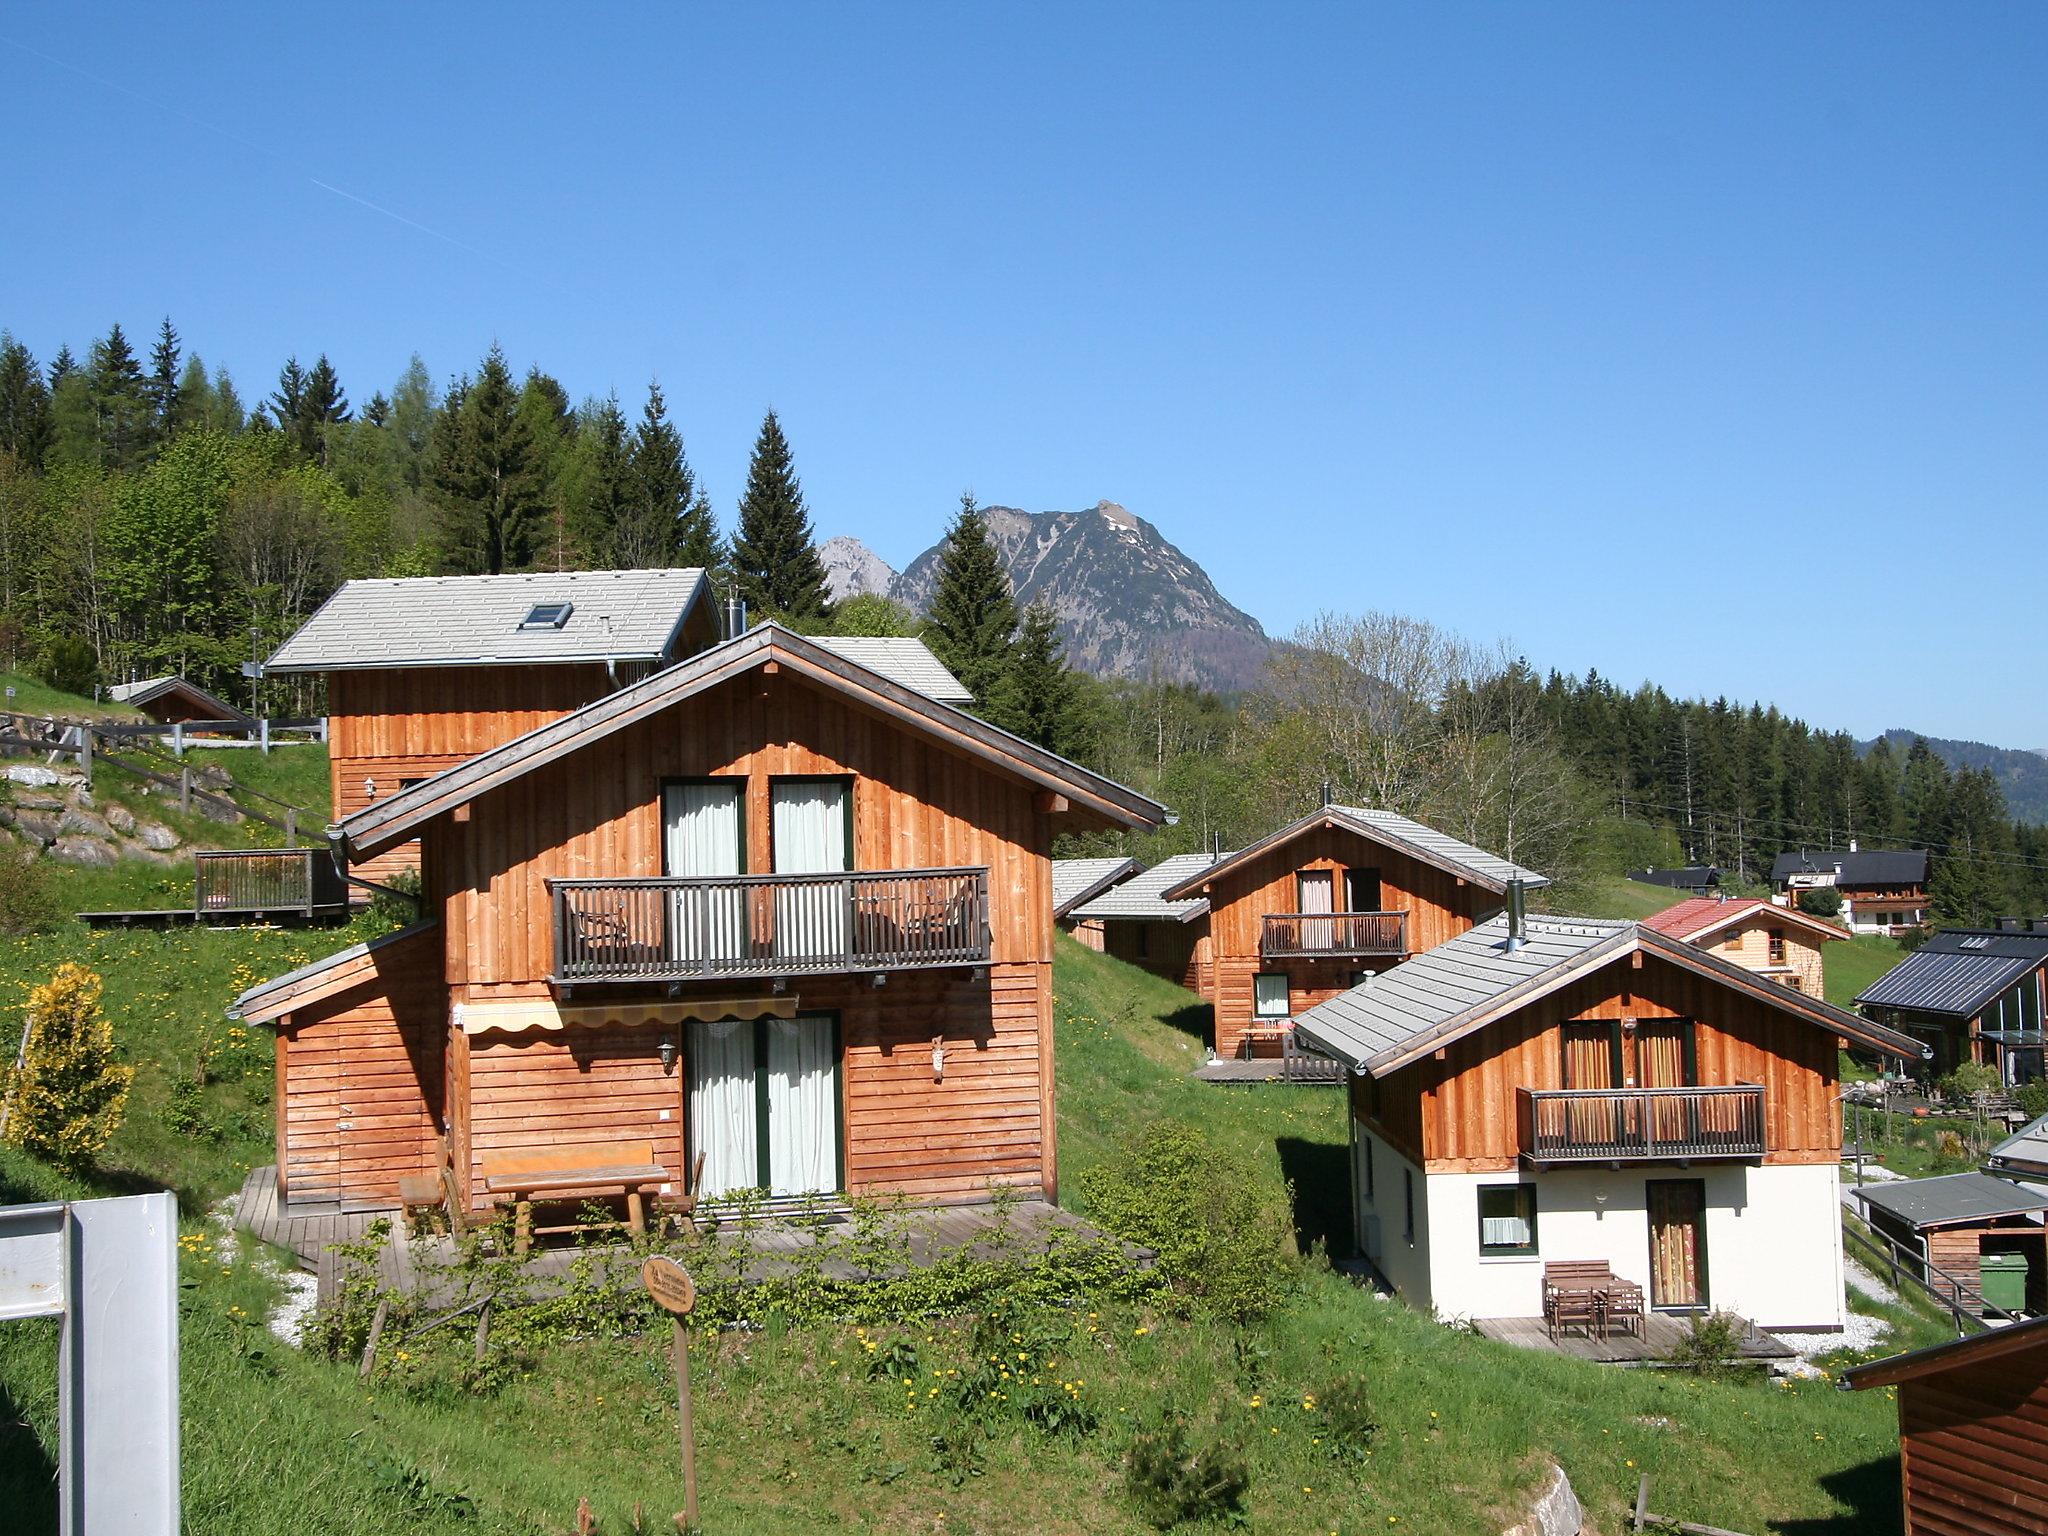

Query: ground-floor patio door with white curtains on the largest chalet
(684, 1014), (840, 1200)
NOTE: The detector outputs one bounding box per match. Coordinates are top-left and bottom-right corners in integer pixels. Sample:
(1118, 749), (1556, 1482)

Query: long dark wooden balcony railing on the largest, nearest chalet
(549, 868), (989, 985)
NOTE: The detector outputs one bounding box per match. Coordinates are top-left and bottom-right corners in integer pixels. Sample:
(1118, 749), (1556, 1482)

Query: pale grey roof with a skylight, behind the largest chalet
(264, 569), (707, 672)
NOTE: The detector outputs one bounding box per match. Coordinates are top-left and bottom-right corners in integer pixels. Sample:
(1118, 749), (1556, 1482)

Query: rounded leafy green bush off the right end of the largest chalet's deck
(1081, 1122), (1292, 1323)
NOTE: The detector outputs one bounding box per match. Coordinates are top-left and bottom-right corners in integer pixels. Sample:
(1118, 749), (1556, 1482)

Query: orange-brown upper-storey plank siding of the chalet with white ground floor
(1352, 954), (1841, 1174)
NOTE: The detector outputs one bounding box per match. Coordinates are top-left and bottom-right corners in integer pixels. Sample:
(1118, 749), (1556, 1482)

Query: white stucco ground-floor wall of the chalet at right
(1425, 1147), (1845, 1327)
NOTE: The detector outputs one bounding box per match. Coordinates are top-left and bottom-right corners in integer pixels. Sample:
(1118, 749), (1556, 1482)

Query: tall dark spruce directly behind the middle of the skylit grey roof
(434, 346), (547, 575)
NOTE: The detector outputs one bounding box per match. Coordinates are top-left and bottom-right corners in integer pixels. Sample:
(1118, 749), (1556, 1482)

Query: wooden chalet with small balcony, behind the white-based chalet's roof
(1163, 805), (1548, 1057)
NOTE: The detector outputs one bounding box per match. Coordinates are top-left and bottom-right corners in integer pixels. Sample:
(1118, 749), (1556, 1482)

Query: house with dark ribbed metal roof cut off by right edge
(1855, 928), (2048, 1083)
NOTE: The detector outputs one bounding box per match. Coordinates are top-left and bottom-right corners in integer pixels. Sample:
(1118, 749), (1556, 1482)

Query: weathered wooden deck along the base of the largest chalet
(236, 1167), (1153, 1300)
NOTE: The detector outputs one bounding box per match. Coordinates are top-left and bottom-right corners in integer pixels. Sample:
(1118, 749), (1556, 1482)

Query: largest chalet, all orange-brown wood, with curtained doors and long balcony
(238, 625), (1165, 1210)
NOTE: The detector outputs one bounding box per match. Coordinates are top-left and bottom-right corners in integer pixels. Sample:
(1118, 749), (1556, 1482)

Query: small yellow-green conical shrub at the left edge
(6, 961), (135, 1169)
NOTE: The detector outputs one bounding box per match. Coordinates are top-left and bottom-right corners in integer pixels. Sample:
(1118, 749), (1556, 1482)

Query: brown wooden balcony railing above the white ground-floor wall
(1518, 1083), (1763, 1163)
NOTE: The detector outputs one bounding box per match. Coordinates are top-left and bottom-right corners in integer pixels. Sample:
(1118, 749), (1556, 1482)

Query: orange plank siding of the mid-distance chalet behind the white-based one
(1206, 827), (1501, 1057)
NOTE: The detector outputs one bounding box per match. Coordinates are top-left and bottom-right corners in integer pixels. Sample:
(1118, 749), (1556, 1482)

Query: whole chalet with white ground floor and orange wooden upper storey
(1294, 909), (1919, 1329)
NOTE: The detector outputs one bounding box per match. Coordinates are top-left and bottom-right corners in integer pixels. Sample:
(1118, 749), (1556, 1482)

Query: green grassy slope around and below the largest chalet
(0, 930), (1896, 1536)
